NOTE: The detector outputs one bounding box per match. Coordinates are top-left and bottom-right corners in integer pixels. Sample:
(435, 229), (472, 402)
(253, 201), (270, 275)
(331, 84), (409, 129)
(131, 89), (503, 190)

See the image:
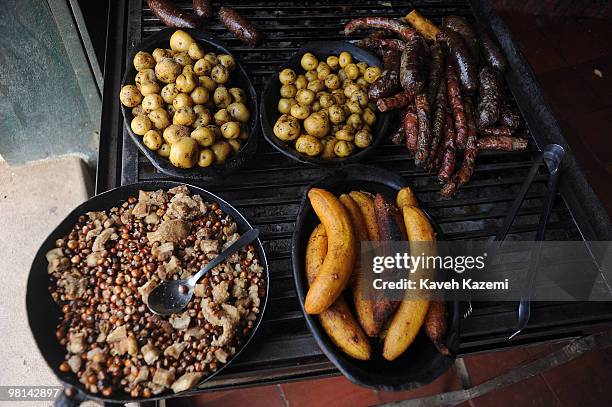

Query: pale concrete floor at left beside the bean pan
(0, 157), (92, 407)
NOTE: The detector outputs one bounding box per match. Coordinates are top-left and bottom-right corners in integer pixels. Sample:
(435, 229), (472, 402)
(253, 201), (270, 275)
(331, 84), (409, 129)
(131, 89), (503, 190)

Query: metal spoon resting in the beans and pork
(148, 229), (259, 315)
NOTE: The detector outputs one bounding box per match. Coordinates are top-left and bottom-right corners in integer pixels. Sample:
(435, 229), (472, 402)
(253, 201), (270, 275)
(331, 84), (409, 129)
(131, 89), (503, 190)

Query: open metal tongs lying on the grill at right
(495, 144), (565, 339)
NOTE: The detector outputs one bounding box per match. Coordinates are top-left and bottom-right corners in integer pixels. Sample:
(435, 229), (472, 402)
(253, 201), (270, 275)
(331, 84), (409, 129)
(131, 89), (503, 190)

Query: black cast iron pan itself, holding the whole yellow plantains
(291, 165), (460, 391)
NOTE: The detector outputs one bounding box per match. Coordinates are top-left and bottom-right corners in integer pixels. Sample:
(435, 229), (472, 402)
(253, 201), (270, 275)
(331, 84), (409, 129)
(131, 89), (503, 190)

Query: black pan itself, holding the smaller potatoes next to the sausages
(260, 41), (391, 167)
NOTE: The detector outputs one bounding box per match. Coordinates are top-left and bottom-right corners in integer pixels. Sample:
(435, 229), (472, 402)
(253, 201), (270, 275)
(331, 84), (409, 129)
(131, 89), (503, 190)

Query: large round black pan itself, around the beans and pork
(26, 181), (270, 406)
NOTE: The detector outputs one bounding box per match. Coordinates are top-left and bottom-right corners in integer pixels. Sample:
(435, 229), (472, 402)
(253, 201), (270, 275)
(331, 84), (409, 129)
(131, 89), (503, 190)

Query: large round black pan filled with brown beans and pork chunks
(26, 181), (269, 404)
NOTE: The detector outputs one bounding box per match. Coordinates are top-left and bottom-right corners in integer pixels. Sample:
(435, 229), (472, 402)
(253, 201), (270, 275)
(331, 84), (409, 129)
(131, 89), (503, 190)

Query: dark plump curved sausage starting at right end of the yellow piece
(438, 28), (478, 93)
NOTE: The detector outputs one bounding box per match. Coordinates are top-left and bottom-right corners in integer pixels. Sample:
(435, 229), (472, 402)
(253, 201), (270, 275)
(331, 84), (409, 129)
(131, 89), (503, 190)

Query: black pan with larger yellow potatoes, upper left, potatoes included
(119, 28), (259, 179)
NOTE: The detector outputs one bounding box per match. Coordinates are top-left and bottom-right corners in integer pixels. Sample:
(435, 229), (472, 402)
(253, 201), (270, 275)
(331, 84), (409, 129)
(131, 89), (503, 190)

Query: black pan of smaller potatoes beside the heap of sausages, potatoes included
(260, 41), (391, 167)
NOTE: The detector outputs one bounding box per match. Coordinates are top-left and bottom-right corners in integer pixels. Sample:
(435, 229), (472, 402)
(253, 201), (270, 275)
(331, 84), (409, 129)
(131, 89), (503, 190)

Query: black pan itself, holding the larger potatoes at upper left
(117, 28), (259, 179)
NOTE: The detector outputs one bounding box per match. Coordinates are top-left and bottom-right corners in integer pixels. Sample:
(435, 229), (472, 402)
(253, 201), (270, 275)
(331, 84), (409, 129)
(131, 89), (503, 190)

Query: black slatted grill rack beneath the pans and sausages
(96, 0), (612, 391)
